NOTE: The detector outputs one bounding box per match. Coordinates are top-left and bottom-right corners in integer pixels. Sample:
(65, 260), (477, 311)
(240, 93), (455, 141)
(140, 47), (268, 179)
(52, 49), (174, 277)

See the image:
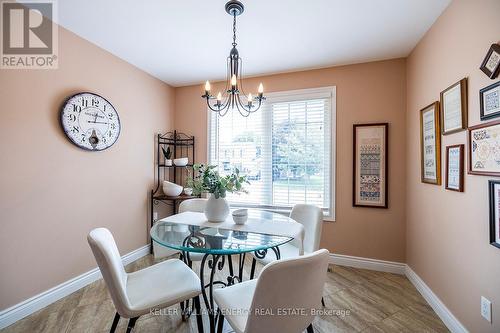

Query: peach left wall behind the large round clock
(0, 28), (175, 310)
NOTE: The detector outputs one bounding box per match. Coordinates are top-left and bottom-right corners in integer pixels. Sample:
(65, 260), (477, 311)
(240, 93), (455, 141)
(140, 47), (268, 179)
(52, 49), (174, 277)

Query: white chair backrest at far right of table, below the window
(290, 204), (323, 252)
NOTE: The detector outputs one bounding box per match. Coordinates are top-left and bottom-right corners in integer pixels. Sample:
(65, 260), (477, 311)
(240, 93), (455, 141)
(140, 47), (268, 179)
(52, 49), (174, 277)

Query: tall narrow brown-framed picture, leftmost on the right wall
(420, 102), (441, 185)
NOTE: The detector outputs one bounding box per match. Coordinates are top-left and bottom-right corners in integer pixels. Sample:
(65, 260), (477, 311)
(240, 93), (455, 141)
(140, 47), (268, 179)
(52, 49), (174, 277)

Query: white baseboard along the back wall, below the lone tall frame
(330, 253), (406, 275)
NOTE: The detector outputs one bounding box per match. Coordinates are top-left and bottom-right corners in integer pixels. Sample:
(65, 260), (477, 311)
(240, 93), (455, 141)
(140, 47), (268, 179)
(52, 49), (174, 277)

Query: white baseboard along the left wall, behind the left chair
(0, 244), (149, 329)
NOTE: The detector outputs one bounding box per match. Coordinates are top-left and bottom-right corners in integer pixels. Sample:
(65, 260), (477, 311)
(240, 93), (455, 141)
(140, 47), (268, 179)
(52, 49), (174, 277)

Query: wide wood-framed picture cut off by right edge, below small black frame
(467, 121), (500, 176)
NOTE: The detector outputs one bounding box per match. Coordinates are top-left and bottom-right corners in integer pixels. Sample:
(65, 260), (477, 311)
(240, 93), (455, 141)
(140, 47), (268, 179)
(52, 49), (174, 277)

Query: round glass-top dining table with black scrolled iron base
(150, 209), (297, 332)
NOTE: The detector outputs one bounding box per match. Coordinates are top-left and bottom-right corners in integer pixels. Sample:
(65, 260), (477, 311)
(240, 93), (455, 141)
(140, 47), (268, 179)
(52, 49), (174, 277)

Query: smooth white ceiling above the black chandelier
(53, 0), (451, 86)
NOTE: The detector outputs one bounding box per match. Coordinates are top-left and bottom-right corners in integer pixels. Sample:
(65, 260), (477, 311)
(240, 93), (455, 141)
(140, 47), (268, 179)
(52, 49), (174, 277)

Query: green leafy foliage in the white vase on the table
(186, 164), (250, 199)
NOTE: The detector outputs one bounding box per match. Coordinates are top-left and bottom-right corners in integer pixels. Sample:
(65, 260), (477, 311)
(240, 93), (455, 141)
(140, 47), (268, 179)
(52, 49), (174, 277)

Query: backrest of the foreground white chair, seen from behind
(245, 249), (329, 333)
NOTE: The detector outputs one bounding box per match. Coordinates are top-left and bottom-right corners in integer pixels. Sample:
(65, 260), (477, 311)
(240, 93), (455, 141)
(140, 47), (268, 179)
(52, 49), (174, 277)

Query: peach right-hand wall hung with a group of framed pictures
(406, 0), (500, 332)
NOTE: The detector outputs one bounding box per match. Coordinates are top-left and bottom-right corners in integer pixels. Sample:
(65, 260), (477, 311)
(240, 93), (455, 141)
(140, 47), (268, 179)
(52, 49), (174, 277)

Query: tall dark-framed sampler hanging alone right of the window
(352, 123), (389, 208)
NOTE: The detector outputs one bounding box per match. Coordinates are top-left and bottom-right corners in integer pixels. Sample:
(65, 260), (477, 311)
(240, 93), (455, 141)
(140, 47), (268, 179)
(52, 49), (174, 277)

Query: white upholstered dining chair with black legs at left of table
(87, 228), (203, 332)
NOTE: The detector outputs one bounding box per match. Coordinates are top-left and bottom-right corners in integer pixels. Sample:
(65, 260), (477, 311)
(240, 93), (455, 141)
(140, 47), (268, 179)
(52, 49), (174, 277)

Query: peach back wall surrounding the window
(175, 59), (406, 262)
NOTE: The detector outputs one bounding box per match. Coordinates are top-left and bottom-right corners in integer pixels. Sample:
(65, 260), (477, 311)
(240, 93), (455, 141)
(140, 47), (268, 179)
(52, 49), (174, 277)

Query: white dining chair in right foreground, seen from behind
(213, 249), (329, 333)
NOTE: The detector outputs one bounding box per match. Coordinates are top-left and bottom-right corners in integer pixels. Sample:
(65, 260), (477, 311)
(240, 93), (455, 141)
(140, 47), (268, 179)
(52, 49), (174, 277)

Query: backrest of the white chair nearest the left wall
(87, 228), (130, 316)
